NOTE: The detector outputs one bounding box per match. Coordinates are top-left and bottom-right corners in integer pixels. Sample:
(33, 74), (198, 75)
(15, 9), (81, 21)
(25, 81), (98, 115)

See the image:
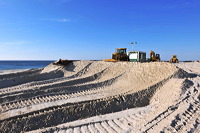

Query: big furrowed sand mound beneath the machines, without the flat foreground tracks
(0, 61), (197, 132)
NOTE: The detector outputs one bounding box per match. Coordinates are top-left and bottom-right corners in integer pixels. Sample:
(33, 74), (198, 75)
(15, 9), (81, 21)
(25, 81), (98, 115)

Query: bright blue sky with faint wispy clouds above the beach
(0, 0), (200, 60)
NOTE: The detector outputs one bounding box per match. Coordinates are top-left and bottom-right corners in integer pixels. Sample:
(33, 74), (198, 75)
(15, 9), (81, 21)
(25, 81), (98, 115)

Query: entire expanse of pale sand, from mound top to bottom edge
(0, 61), (200, 133)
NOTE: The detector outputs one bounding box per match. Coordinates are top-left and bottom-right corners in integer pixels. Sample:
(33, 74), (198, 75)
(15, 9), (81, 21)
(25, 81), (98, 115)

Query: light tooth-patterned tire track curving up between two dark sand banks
(0, 72), (121, 113)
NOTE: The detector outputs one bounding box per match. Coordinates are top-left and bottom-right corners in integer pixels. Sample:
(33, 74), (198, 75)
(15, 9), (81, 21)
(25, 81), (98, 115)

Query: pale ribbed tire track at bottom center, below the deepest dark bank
(30, 109), (152, 133)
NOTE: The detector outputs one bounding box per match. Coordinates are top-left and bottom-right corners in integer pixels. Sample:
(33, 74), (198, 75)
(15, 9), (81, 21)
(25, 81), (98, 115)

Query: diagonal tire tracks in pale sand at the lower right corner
(140, 77), (200, 132)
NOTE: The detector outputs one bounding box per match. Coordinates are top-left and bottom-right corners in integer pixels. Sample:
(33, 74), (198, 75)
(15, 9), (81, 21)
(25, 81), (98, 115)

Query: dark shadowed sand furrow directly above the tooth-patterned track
(0, 70), (105, 103)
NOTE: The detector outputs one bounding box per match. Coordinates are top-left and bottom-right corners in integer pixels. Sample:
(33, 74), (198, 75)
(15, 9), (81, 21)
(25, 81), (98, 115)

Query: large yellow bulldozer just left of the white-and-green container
(104, 48), (129, 61)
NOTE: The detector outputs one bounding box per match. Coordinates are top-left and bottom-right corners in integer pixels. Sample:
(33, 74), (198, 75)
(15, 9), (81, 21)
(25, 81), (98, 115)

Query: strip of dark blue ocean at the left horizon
(0, 61), (54, 70)
